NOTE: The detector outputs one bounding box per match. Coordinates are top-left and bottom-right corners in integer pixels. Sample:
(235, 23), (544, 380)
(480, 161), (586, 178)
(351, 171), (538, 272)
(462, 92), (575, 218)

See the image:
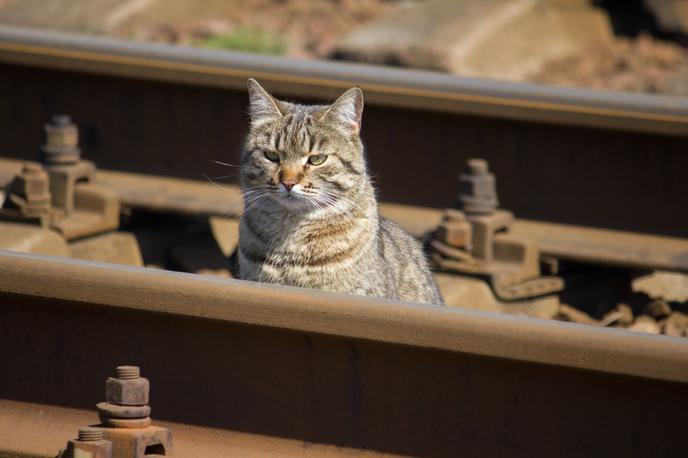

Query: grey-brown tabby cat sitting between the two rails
(237, 79), (444, 305)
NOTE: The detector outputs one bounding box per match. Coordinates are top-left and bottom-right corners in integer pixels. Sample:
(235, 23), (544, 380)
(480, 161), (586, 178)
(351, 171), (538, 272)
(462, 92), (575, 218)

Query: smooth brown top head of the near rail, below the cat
(0, 251), (688, 383)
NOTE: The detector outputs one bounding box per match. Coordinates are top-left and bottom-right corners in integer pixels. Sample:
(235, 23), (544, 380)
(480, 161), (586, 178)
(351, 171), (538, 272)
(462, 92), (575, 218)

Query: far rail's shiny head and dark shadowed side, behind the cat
(0, 26), (688, 236)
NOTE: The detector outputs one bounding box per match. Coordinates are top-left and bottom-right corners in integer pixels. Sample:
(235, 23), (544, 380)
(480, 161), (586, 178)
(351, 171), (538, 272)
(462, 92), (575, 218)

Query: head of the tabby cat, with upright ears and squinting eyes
(241, 79), (367, 211)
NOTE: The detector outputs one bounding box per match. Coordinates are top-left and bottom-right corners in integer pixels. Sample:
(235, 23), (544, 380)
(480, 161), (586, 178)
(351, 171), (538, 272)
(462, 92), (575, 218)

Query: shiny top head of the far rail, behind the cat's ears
(0, 26), (688, 136)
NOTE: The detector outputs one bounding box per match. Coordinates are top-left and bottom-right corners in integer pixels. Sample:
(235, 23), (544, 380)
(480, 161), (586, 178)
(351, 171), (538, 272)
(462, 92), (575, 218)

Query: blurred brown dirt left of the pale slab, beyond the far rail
(0, 0), (398, 58)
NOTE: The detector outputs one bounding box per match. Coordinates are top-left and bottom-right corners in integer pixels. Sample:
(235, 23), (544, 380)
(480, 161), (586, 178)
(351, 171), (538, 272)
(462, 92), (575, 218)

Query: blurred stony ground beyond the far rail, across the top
(0, 0), (688, 96)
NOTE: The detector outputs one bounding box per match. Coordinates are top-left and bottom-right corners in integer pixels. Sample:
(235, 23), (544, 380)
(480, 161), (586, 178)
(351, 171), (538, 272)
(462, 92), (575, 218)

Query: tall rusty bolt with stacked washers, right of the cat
(459, 159), (499, 215)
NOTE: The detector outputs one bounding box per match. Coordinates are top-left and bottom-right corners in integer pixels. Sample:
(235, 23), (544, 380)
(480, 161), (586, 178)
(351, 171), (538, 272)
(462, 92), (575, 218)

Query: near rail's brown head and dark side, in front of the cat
(0, 253), (688, 457)
